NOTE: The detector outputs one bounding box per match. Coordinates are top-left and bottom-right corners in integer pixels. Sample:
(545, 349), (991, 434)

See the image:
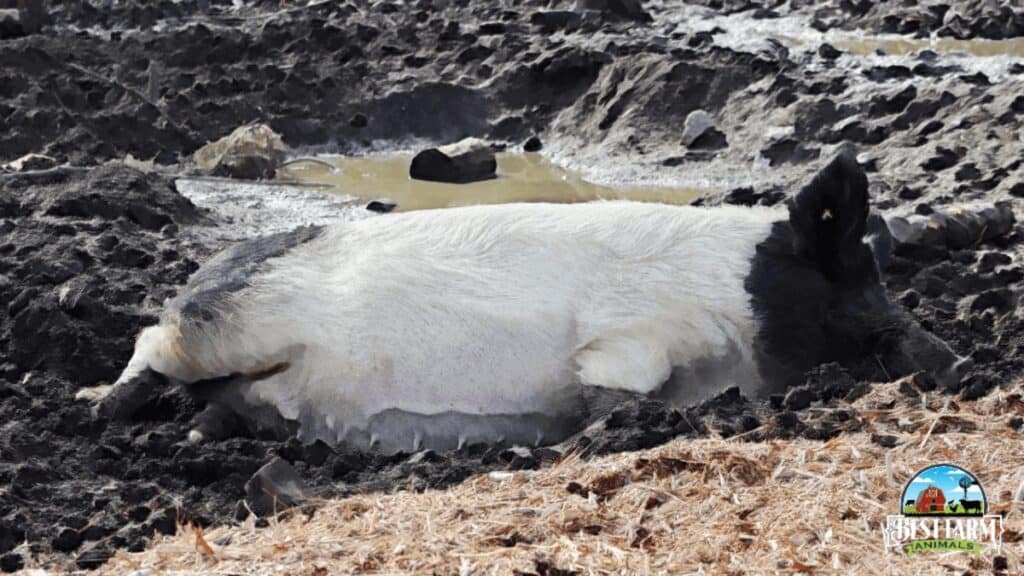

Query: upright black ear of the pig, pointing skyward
(790, 151), (867, 281)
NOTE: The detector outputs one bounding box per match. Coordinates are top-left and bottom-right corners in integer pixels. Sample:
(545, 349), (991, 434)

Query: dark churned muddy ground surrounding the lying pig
(0, 0), (1024, 570)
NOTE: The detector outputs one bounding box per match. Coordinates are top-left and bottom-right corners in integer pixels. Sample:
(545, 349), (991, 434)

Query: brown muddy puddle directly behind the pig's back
(278, 153), (710, 210)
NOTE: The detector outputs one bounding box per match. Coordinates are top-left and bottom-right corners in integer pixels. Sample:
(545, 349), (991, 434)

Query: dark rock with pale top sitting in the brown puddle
(409, 138), (498, 183)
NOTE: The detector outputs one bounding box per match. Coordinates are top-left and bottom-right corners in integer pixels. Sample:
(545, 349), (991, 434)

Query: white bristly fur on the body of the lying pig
(116, 202), (783, 444)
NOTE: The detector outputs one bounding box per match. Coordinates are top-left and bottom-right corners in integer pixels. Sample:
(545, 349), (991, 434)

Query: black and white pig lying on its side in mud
(83, 153), (969, 452)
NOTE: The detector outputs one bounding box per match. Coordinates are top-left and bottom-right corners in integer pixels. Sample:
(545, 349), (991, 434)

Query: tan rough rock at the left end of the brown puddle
(195, 124), (288, 180)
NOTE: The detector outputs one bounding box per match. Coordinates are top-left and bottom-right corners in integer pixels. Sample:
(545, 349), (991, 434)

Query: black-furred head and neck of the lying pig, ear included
(745, 154), (956, 392)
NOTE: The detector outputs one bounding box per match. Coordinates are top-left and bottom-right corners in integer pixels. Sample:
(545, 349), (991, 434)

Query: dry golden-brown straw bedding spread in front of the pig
(92, 382), (1024, 575)
